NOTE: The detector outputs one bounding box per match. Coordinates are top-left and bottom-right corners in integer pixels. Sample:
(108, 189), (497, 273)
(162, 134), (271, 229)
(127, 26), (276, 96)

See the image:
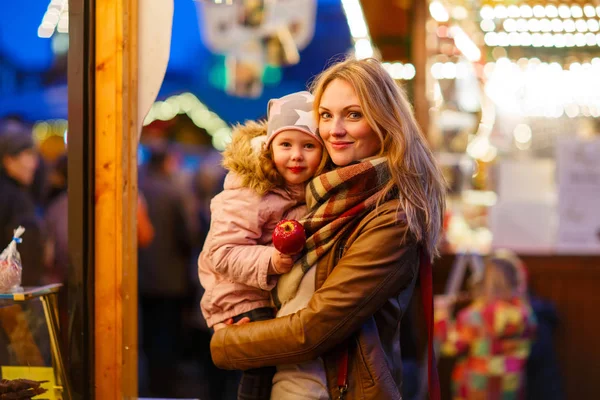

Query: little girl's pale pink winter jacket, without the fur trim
(198, 120), (306, 327)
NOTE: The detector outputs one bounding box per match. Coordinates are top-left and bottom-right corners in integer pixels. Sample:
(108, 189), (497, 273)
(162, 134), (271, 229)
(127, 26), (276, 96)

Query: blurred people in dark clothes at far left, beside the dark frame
(0, 118), (62, 286)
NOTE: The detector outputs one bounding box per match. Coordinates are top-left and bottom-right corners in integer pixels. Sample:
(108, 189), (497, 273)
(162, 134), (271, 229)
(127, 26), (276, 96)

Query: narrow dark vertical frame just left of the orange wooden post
(67, 0), (96, 400)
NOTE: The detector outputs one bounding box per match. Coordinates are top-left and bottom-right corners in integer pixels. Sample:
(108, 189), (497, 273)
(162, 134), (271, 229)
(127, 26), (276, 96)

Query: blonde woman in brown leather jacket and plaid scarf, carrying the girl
(211, 59), (445, 400)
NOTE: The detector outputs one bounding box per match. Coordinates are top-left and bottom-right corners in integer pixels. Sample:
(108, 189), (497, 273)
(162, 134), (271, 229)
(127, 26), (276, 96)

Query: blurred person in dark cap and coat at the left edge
(0, 130), (44, 286)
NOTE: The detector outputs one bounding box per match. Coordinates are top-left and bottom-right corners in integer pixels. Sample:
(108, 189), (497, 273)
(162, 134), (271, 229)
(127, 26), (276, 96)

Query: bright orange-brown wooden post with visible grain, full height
(95, 0), (138, 400)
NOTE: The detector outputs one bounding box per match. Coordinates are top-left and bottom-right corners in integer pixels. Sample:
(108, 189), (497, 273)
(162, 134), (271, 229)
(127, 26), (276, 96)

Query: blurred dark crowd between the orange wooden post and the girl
(138, 140), (237, 399)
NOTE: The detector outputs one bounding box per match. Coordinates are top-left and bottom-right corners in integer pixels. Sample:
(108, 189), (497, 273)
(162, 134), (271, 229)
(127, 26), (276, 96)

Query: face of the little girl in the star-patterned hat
(271, 130), (323, 185)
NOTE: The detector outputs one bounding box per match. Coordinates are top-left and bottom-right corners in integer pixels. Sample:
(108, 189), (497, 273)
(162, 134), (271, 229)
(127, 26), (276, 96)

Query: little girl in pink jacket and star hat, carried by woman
(198, 92), (328, 399)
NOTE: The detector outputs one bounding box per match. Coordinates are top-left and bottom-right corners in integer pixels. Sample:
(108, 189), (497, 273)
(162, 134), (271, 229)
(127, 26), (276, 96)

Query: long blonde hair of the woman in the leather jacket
(311, 58), (446, 257)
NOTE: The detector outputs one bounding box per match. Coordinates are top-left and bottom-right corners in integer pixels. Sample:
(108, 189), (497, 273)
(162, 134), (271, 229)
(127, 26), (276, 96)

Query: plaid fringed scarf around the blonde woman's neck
(271, 157), (390, 308)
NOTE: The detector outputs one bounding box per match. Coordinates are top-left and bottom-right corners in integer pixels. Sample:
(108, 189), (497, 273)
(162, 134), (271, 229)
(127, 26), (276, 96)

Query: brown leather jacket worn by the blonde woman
(211, 201), (419, 400)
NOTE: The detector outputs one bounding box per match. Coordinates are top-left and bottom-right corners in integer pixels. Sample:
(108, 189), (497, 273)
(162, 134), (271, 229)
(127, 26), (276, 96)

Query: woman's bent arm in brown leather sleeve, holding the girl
(211, 202), (418, 369)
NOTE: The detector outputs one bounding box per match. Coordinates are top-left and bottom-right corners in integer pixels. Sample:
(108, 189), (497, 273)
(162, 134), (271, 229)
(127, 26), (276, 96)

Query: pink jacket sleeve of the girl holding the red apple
(203, 189), (277, 290)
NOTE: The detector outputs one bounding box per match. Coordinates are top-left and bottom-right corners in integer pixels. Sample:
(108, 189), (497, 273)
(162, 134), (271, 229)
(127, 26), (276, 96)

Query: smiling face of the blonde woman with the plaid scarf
(319, 79), (381, 166)
